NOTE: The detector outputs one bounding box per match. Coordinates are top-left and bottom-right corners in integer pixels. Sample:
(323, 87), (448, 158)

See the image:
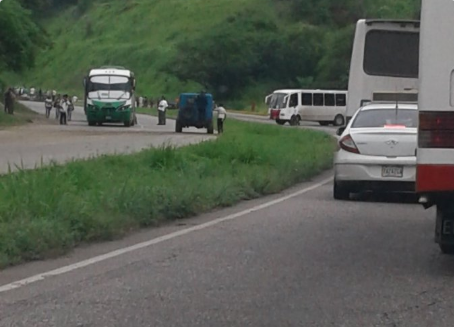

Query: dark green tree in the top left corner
(0, 0), (45, 72)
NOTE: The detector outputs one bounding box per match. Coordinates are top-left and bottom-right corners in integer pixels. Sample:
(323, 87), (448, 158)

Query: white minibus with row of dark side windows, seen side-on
(271, 90), (347, 126)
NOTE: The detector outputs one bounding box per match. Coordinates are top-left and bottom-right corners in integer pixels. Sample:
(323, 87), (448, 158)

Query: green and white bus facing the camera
(84, 67), (136, 127)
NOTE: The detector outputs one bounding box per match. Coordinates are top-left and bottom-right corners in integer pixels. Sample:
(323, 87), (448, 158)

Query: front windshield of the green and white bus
(88, 75), (132, 100)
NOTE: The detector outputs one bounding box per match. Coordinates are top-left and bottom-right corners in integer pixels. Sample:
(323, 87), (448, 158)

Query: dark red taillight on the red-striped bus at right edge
(418, 112), (454, 149)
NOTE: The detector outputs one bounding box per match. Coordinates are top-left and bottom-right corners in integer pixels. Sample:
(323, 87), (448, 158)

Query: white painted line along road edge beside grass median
(0, 177), (334, 293)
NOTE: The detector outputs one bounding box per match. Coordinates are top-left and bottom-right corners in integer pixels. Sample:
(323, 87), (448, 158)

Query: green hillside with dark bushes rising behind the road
(5, 0), (419, 107)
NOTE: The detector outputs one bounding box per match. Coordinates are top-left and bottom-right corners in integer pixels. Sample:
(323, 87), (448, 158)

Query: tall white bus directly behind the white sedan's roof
(346, 19), (420, 122)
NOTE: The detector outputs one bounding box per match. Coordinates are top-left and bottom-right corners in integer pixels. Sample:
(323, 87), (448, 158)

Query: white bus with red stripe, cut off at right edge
(416, 0), (454, 254)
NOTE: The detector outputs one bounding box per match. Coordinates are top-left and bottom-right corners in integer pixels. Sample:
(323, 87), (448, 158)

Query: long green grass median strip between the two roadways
(0, 120), (334, 267)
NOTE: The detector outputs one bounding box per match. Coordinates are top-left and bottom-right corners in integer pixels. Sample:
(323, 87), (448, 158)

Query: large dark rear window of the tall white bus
(364, 30), (419, 78)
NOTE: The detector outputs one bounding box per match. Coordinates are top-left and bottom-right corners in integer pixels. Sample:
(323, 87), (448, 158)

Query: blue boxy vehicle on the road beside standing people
(175, 93), (214, 134)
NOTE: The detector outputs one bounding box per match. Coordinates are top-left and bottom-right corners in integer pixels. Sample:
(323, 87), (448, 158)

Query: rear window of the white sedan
(352, 109), (418, 128)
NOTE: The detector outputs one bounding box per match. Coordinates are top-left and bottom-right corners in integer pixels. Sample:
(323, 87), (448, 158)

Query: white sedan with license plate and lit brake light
(333, 104), (418, 200)
